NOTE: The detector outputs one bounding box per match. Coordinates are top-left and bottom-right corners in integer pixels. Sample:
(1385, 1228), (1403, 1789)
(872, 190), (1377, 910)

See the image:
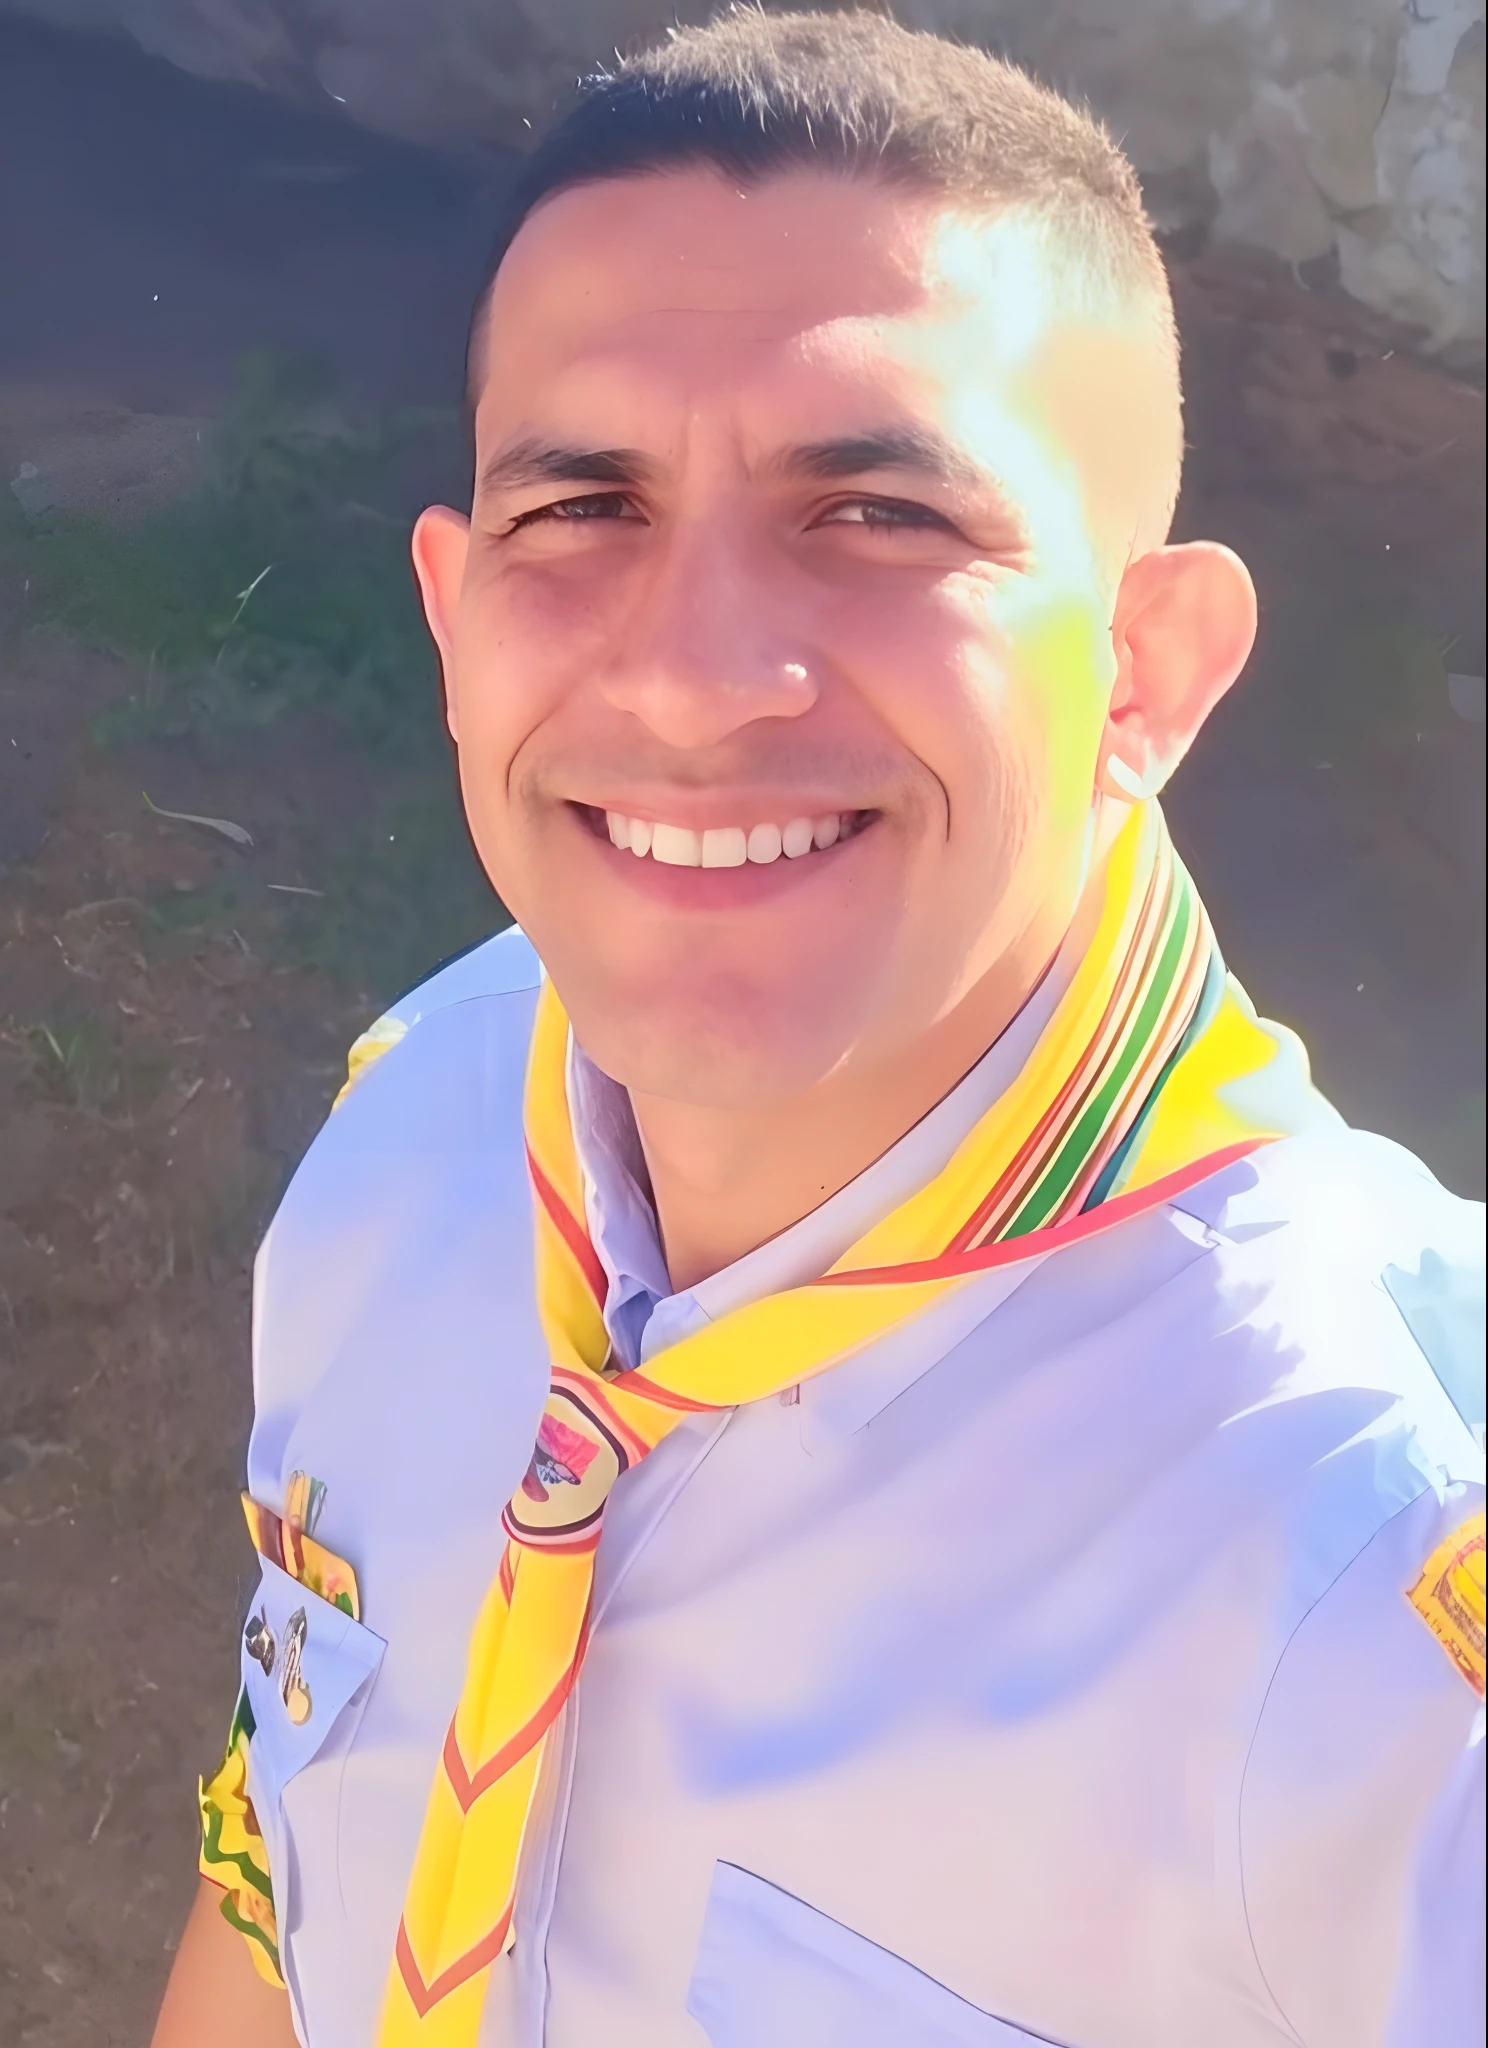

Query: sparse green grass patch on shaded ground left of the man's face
(0, 354), (506, 999)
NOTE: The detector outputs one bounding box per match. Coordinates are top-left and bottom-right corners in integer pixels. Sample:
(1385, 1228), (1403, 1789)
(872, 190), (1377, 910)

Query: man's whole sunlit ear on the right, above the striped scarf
(1099, 541), (1257, 803)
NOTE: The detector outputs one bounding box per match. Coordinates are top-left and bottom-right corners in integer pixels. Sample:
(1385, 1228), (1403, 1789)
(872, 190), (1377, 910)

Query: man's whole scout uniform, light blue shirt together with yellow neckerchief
(203, 807), (1484, 2048)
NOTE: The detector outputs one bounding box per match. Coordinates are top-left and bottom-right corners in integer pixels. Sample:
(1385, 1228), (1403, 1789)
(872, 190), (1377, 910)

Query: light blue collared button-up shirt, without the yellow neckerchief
(244, 934), (1484, 2048)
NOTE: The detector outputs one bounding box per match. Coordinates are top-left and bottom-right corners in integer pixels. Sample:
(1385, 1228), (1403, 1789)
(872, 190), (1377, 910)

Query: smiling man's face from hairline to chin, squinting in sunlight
(415, 170), (1175, 1108)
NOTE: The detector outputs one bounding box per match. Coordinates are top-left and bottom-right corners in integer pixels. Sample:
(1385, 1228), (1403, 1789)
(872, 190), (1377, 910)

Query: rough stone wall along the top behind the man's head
(0, 0), (1484, 365)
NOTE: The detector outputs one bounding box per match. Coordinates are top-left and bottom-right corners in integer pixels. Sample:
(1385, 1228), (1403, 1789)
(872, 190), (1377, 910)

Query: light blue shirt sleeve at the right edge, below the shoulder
(1240, 1485), (1484, 2048)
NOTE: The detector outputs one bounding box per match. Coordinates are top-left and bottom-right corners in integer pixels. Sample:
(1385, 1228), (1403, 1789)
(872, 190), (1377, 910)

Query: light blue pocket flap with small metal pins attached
(242, 1556), (387, 1788)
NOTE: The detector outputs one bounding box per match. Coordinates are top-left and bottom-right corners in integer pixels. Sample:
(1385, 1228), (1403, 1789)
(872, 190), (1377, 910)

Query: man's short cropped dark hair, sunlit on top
(469, 6), (1177, 403)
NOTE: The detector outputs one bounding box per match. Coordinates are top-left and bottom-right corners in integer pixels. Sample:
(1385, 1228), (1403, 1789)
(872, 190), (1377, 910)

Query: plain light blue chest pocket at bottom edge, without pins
(688, 1864), (1072, 2048)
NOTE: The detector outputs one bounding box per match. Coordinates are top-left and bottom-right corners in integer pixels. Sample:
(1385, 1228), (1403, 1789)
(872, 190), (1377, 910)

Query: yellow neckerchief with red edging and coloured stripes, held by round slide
(379, 805), (1316, 2048)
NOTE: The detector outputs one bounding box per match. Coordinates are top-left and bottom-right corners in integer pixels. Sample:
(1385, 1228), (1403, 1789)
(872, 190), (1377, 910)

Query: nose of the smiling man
(598, 532), (819, 750)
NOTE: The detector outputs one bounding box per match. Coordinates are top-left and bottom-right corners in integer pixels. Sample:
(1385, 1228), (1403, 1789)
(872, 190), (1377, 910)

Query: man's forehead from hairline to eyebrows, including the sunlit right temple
(475, 168), (1181, 573)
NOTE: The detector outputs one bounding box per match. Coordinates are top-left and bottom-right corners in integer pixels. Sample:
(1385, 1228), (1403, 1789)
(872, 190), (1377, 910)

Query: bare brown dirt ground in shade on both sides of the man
(0, 16), (1484, 2048)
